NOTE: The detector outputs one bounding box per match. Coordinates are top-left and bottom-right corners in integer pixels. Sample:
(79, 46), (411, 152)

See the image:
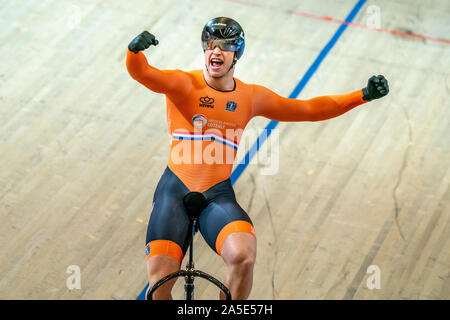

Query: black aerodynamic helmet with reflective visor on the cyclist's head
(202, 17), (245, 59)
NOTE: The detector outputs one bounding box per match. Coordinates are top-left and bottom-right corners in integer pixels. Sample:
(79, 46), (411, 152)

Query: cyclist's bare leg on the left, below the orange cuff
(147, 255), (180, 300)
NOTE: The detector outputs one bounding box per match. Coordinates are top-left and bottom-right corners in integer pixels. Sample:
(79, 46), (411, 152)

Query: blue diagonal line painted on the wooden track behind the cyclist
(137, 0), (367, 300)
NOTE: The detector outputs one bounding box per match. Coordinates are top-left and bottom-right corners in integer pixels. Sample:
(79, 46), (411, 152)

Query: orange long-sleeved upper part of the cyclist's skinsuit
(127, 50), (367, 192)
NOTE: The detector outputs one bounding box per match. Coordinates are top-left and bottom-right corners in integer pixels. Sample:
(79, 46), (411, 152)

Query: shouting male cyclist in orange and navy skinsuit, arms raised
(126, 17), (389, 299)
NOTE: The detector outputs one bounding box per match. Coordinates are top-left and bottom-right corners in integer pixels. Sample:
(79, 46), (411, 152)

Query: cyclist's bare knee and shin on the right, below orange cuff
(220, 232), (256, 300)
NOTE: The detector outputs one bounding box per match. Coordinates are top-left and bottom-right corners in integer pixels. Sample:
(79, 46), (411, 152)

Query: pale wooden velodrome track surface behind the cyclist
(0, 0), (450, 299)
